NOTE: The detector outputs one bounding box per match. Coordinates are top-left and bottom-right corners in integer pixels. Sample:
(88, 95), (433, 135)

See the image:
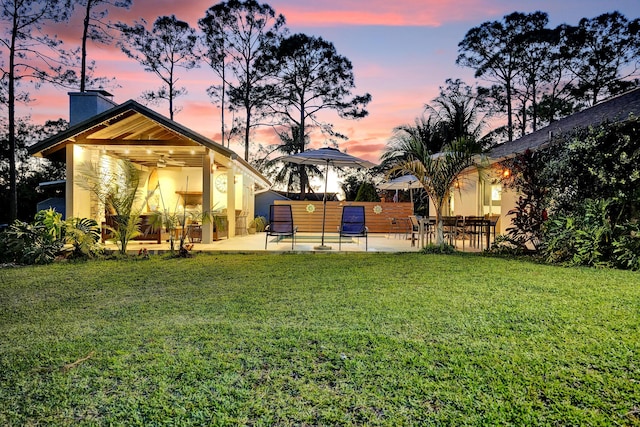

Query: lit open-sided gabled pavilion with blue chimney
(29, 91), (271, 243)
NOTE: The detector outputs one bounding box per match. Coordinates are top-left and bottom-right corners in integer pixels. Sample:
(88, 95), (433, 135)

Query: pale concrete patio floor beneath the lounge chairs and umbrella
(117, 233), (488, 254)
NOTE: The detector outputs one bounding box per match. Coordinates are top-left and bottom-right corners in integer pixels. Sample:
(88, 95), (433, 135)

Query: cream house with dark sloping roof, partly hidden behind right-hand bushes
(450, 88), (640, 234)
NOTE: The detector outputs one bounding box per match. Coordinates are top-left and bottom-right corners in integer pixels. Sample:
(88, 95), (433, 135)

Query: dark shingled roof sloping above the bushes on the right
(489, 88), (640, 159)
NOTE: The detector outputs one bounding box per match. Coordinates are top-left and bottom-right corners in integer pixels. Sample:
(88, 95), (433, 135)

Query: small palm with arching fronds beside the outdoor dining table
(390, 136), (478, 245)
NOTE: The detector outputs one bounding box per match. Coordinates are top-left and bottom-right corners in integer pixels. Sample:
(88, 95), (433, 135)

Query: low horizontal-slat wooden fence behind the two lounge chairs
(275, 200), (413, 233)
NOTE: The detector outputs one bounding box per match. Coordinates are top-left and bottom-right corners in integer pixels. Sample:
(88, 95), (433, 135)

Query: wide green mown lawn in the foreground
(0, 254), (640, 426)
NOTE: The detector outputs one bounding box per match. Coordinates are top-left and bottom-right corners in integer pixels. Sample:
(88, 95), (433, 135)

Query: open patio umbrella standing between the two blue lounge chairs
(278, 147), (375, 250)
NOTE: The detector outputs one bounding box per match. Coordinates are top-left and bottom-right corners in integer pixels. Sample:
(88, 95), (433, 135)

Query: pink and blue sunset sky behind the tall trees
(20, 0), (640, 163)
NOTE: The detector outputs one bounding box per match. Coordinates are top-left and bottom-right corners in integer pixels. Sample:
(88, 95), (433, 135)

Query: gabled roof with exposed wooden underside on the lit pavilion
(28, 100), (271, 187)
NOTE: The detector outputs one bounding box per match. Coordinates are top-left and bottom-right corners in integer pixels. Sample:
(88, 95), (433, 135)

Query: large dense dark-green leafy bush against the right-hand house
(496, 116), (640, 269)
